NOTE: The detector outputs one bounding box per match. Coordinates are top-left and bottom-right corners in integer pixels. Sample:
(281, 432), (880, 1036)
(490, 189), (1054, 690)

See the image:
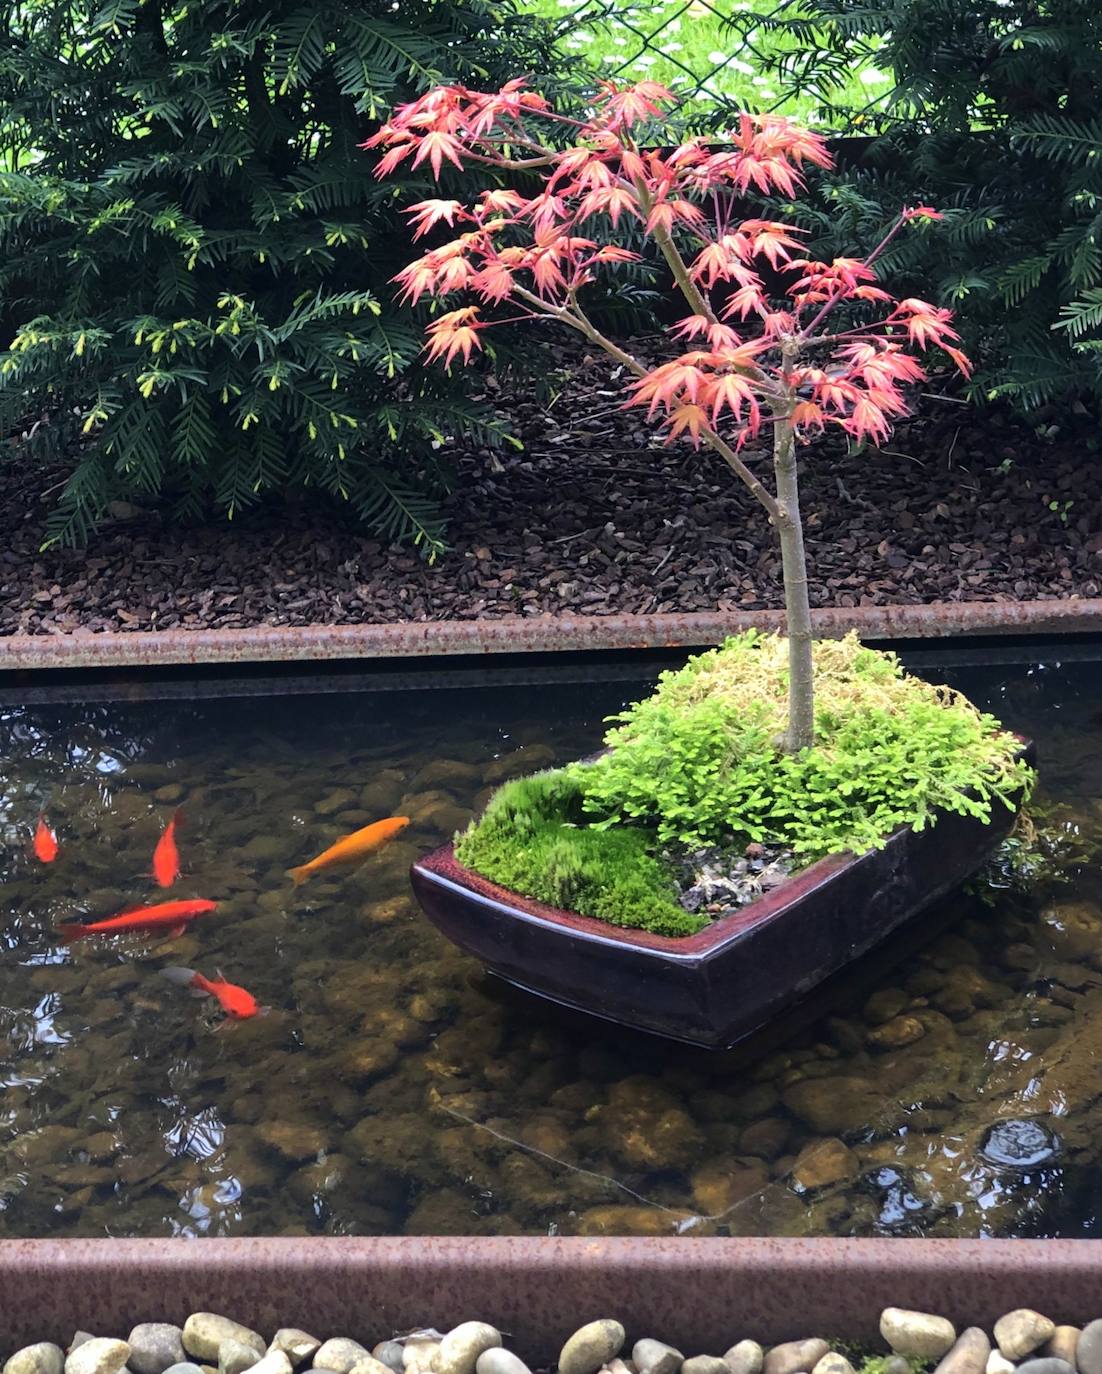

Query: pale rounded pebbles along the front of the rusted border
(3, 1307), (1102, 1374)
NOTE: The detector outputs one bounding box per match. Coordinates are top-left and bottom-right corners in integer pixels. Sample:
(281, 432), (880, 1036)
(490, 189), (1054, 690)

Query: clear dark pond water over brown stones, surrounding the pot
(0, 650), (1102, 1237)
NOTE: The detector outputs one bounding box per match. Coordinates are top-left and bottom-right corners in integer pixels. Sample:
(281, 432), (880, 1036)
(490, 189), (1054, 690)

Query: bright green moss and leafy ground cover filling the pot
(456, 631), (1032, 934)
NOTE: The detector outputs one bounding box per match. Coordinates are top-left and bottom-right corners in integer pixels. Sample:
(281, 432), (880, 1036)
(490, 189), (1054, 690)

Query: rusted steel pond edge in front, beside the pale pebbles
(0, 1237), (1102, 1364)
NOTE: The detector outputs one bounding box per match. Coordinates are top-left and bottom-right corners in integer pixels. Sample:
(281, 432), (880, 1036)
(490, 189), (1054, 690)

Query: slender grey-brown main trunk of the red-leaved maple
(774, 409), (815, 753)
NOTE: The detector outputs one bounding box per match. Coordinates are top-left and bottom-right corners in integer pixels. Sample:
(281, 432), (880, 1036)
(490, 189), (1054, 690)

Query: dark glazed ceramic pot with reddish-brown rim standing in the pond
(411, 742), (1033, 1048)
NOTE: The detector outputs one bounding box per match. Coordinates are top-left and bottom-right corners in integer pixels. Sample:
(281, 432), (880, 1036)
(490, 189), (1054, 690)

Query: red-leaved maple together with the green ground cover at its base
(367, 81), (1028, 934)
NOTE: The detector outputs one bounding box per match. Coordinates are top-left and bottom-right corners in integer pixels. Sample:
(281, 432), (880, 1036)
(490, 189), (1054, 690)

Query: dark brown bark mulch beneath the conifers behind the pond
(0, 353), (1102, 635)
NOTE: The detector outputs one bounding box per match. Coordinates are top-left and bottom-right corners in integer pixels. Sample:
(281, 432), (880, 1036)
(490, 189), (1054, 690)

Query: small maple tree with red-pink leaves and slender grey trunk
(366, 81), (969, 752)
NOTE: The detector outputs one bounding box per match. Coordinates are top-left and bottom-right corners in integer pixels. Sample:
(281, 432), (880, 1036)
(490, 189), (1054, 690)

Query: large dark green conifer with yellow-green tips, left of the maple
(0, 0), (550, 551)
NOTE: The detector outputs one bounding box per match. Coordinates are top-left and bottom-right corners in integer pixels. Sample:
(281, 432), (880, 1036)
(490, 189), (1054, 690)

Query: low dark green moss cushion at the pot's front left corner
(455, 767), (708, 936)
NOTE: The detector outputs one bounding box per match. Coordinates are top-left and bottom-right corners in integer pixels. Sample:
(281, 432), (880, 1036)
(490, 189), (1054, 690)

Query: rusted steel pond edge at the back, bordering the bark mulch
(0, 599), (1102, 671)
